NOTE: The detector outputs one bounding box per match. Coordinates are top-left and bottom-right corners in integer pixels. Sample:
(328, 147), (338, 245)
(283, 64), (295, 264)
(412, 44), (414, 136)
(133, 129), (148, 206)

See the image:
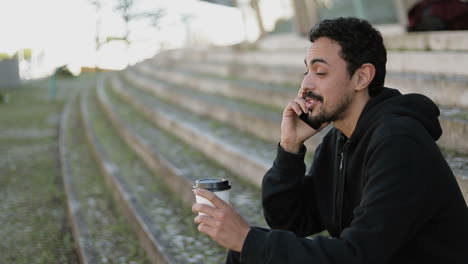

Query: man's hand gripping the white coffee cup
(192, 189), (250, 252)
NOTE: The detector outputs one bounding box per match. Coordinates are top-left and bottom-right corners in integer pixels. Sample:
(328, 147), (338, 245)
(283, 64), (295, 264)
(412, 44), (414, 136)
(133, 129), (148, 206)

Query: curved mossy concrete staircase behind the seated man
(61, 32), (468, 264)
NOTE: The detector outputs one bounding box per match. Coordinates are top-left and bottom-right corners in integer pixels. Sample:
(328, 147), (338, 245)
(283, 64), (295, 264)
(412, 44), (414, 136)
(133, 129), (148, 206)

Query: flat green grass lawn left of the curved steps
(0, 77), (81, 264)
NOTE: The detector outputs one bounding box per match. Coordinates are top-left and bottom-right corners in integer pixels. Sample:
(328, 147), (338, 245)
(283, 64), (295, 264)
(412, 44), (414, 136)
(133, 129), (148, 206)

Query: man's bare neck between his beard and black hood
(333, 91), (370, 138)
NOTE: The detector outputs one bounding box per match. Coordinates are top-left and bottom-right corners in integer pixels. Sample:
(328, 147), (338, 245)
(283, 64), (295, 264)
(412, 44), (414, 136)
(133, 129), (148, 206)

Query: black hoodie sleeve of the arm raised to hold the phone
(262, 145), (323, 236)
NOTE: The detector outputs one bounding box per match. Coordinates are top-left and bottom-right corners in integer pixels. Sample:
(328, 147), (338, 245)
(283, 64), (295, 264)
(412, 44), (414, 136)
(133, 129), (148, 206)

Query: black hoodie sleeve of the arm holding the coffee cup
(241, 136), (443, 264)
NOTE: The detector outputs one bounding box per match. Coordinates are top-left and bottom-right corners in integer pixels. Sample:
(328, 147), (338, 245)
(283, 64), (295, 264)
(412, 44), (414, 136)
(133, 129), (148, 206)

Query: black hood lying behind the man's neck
(351, 88), (442, 141)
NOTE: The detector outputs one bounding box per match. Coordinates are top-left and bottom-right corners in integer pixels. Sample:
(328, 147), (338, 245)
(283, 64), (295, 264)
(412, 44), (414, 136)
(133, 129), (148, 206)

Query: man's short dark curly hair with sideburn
(309, 17), (387, 97)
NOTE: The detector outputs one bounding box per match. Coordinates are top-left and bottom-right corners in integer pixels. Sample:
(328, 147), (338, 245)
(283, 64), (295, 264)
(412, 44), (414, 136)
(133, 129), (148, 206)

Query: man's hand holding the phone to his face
(280, 97), (328, 153)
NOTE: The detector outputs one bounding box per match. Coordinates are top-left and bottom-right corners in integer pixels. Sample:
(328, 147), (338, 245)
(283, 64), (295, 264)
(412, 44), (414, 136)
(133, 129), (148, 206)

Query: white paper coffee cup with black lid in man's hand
(193, 178), (231, 214)
